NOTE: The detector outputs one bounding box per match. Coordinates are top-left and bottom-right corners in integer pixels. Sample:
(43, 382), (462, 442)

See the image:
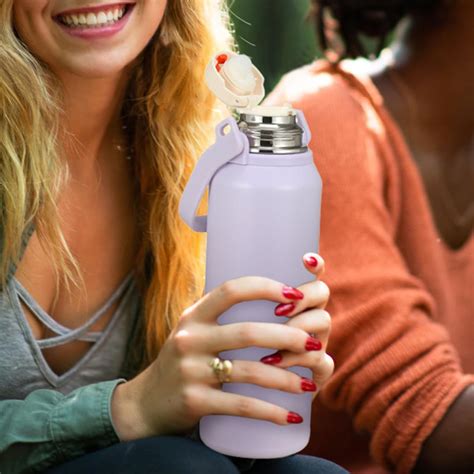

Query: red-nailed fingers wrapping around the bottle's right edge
(261, 253), (334, 400)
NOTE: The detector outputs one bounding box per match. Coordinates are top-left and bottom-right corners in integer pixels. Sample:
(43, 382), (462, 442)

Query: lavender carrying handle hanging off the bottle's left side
(179, 117), (245, 232)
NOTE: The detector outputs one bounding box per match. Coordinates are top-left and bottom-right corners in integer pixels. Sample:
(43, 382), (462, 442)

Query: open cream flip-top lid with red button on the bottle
(205, 51), (294, 115)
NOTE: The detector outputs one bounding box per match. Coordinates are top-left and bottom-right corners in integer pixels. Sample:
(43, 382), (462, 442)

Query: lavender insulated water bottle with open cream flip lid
(179, 52), (322, 459)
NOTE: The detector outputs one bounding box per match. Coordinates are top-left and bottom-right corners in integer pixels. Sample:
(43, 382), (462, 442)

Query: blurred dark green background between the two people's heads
(227, 0), (320, 93)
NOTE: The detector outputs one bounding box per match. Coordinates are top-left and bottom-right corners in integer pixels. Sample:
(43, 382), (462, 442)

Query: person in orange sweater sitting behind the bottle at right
(266, 0), (474, 474)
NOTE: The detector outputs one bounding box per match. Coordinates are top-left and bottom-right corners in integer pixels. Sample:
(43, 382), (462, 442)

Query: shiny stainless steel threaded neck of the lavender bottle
(238, 113), (307, 154)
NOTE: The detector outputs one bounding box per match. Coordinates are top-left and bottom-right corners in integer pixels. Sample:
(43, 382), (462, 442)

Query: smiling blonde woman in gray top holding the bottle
(0, 0), (342, 474)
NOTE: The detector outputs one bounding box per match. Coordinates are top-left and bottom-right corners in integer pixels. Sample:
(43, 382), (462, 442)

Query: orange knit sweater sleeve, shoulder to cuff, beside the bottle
(266, 70), (474, 473)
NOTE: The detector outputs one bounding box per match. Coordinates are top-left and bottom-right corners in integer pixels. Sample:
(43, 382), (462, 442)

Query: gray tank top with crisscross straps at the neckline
(0, 273), (139, 400)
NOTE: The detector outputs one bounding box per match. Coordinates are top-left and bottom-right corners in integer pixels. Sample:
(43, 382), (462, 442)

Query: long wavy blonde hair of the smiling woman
(0, 0), (235, 368)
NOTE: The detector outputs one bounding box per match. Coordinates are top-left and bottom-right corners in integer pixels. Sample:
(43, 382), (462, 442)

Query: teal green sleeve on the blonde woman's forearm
(0, 379), (125, 474)
